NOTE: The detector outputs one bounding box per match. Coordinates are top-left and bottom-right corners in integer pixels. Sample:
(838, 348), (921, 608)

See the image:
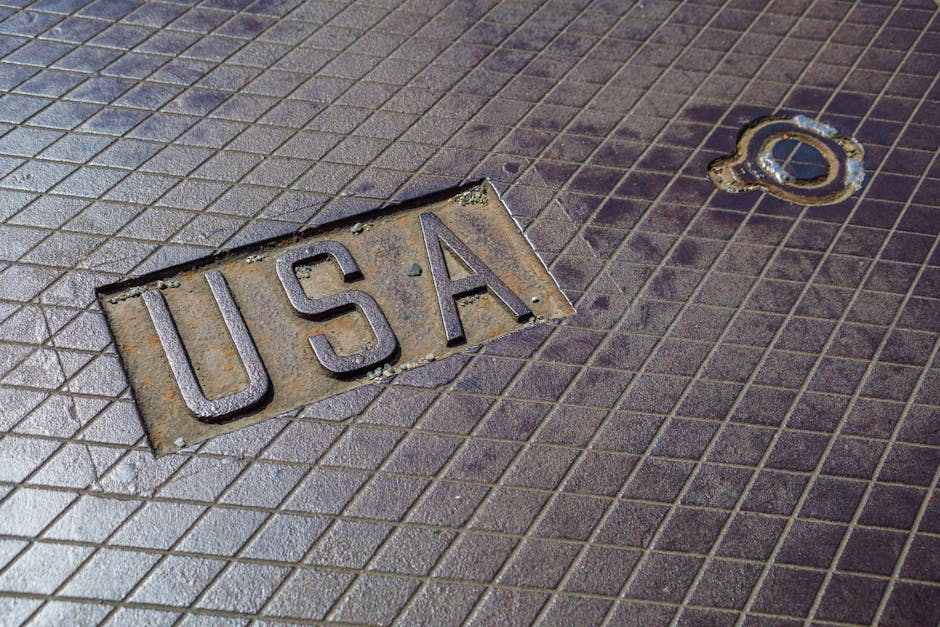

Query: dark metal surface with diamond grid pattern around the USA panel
(0, 0), (940, 625)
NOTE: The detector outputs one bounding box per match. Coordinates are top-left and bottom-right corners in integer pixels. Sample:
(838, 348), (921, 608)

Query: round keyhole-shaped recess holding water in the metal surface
(709, 115), (865, 205)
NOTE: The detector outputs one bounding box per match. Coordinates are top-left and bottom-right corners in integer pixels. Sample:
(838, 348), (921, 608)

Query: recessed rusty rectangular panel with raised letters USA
(98, 181), (574, 455)
